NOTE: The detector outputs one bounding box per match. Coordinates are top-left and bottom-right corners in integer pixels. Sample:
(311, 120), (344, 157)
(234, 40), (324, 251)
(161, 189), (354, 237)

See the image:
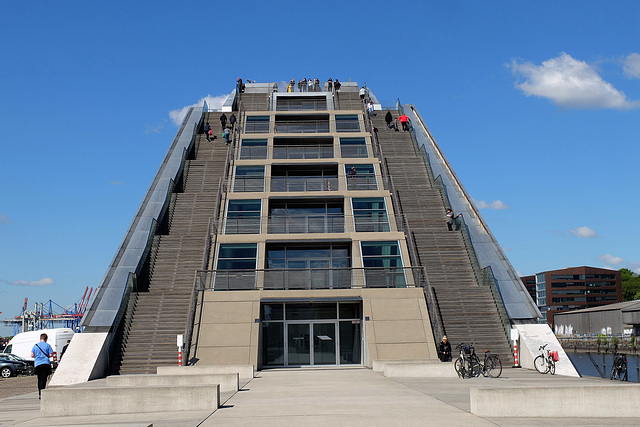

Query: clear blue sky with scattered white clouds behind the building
(0, 0), (640, 335)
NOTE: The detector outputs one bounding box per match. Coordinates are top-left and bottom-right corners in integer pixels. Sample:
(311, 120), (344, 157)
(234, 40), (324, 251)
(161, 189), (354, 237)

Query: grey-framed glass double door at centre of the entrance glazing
(286, 322), (338, 366)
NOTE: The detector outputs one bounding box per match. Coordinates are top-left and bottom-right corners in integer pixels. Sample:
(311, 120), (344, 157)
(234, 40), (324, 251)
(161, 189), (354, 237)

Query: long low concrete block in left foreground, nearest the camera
(40, 384), (220, 417)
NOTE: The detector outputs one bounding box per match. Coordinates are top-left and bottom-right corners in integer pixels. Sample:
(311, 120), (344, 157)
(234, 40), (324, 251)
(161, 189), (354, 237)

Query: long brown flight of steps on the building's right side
(372, 111), (513, 366)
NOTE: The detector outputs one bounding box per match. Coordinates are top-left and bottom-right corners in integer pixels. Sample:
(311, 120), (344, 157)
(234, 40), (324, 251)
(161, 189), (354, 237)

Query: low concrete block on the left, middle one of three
(107, 374), (240, 393)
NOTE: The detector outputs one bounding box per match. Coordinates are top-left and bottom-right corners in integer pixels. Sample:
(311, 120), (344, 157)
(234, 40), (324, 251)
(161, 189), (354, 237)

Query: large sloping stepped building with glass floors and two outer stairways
(57, 82), (540, 384)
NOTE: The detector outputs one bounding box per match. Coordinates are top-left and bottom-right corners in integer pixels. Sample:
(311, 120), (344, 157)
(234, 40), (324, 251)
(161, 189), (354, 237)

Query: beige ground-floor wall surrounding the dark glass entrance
(191, 288), (437, 369)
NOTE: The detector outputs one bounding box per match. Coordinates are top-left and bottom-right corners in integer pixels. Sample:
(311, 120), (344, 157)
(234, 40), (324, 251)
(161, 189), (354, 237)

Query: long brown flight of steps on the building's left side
(111, 113), (229, 374)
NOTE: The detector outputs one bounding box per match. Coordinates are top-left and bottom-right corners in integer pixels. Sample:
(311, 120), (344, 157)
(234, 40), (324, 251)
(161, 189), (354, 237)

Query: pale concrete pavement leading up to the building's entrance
(0, 367), (640, 427)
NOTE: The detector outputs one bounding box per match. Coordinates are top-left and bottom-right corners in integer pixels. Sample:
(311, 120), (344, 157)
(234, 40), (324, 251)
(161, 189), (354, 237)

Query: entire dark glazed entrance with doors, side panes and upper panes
(261, 301), (363, 367)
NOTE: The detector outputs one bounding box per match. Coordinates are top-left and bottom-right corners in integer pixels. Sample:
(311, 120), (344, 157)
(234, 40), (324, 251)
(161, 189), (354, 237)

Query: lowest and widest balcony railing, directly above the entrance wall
(196, 267), (427, 291)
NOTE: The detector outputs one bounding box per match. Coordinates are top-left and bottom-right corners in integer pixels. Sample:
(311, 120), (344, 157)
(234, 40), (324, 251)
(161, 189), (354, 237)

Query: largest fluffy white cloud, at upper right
(511, 52), (640, 110)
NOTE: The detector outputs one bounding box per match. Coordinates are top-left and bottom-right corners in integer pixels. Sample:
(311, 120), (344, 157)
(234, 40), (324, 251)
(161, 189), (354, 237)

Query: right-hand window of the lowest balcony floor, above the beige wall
(360, 241), (407, 288)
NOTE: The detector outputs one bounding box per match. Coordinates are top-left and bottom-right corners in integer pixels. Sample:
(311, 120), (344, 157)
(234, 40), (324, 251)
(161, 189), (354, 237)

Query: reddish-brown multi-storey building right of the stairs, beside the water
(521, 266), (622, 326)
